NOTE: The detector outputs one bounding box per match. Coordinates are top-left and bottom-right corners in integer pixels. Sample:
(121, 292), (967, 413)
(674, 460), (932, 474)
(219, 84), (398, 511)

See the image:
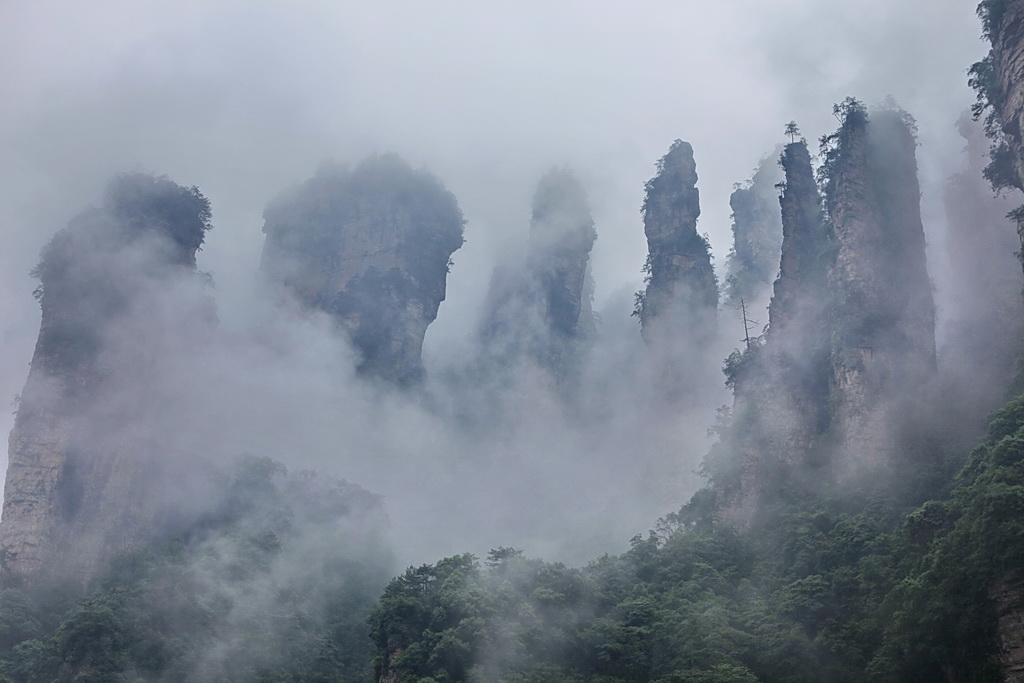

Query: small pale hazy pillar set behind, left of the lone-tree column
(725, 150), (782, 310)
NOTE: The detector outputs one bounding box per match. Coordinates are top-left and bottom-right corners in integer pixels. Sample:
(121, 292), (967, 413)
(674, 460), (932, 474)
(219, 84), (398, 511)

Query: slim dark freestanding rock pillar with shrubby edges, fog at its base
(637, 140), (718, 346)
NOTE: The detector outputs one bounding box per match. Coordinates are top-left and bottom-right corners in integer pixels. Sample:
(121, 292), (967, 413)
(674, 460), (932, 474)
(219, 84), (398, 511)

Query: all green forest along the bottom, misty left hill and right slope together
(0, 387), (1024, 683)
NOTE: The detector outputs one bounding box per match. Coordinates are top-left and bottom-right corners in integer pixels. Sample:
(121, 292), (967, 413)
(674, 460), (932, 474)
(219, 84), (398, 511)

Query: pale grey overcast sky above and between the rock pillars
(0, 0), (985, 540)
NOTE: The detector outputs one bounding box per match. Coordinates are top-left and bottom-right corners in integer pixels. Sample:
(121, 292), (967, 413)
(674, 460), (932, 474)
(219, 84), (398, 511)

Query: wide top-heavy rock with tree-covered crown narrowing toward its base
(262, 155), (464, 384)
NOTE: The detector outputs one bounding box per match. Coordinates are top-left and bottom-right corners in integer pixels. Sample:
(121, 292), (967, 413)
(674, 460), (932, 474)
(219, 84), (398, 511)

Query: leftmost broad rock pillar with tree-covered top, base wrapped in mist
(0, 174), (215, 575)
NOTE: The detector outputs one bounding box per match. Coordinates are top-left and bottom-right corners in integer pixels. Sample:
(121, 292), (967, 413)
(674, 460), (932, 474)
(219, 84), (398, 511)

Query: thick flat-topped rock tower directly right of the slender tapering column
(825, 102), (935, 473)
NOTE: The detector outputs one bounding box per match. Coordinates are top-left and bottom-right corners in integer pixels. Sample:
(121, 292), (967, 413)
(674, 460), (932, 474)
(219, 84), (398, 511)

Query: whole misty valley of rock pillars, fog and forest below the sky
(0, 0), (1024, 683)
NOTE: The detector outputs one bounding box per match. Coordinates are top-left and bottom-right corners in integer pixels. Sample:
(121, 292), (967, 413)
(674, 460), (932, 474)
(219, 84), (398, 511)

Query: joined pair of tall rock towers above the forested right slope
(715, 99), (936, 525)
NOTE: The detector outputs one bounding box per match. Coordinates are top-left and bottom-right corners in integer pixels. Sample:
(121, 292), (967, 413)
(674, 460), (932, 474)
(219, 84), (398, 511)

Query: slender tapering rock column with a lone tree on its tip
(719, 140), (830, 526)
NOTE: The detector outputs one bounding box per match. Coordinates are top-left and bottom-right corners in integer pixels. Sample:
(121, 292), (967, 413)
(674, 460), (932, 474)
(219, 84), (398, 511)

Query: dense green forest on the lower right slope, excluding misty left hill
(372, 387), (1024, 683)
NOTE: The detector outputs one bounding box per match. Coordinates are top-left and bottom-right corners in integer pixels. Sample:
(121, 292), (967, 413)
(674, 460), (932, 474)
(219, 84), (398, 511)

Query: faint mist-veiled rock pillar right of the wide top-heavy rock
(480, 168), (597, 377)
